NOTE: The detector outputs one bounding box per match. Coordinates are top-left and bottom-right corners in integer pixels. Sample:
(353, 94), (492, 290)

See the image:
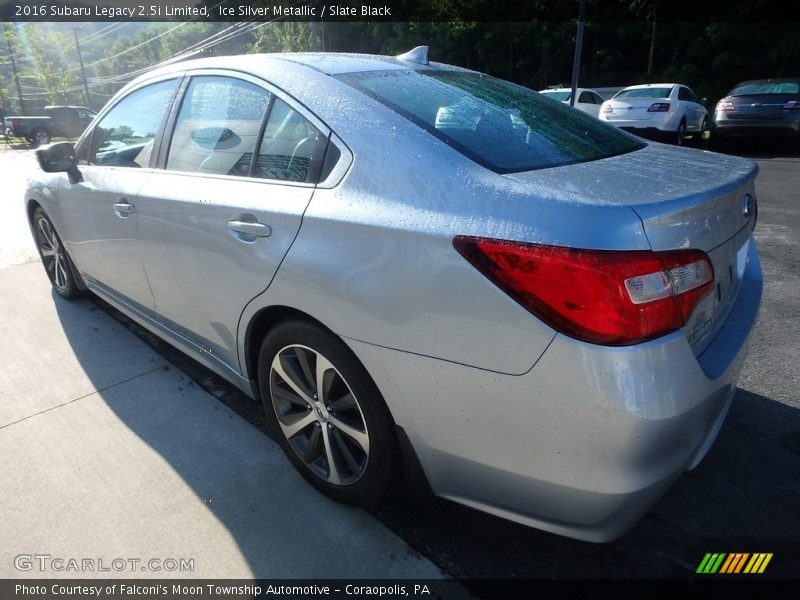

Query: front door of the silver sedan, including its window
(59, 76), (177, 309)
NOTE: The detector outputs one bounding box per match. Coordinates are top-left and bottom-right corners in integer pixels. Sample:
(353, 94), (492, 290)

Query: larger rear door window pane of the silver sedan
(167, 76), (270, 176)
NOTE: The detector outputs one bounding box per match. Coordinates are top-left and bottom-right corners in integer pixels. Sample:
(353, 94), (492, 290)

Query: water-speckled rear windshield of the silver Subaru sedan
(339, 71), (644, 173)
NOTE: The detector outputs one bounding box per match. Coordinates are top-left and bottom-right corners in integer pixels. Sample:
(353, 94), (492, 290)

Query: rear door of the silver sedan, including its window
(137, 71), (329, 371)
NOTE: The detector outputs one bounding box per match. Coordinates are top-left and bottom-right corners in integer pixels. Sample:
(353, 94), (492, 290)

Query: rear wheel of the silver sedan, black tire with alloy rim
(258, 320), (400, 506)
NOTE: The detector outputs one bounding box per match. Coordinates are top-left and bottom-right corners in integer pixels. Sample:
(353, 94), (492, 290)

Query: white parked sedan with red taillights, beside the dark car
(600, 83), (708, 146)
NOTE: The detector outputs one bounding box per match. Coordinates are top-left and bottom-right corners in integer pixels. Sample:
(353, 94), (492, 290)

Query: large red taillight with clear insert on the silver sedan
(453, 236), (714, 346)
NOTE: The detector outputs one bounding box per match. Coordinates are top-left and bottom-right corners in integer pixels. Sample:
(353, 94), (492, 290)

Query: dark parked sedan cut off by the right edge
(711, 79), (800, 144)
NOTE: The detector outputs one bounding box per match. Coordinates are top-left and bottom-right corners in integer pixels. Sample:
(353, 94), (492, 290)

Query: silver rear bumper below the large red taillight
(348, 239), (762, 542)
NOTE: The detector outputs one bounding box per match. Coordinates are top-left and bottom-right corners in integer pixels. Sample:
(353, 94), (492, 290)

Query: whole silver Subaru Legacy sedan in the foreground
(25, 49), (761, 541)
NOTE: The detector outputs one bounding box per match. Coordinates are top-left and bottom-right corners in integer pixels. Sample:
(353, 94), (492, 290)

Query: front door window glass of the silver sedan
(90, 80), (176, 167)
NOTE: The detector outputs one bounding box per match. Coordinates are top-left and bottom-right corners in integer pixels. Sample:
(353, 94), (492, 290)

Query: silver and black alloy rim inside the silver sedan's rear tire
(269, 345), (370, 486)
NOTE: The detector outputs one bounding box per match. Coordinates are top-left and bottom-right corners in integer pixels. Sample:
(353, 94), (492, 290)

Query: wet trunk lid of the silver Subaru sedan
(510, 144), (758, 354)
